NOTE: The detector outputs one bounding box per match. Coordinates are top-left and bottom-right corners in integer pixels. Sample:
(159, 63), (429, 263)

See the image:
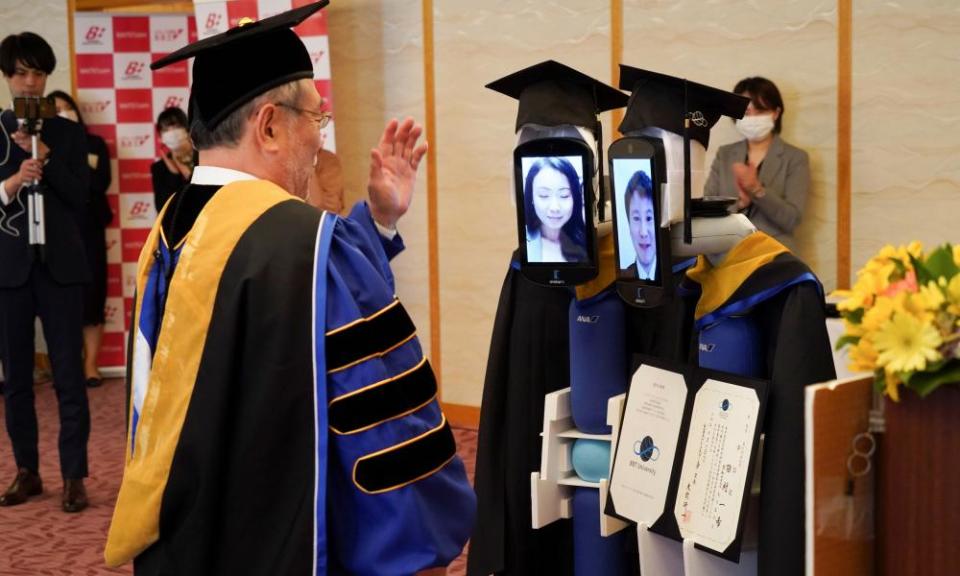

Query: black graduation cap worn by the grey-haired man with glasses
(150, 0), (330, 130)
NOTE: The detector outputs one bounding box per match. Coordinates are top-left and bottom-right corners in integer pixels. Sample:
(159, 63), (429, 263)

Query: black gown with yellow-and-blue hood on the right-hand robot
(680, 232), (836, 576)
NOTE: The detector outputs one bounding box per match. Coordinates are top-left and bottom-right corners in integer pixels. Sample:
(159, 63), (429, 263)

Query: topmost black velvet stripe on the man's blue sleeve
(327, 300), (416, 372)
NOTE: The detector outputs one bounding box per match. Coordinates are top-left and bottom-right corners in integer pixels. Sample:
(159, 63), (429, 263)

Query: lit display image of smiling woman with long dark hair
(523, 157), (587, 262)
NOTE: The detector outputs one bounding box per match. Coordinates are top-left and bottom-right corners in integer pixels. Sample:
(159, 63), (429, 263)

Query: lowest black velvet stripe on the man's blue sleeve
(353, 418), (457, 494)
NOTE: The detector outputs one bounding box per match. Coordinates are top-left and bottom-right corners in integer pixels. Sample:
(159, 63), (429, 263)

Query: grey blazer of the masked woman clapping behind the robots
(703, 136), (810, 250)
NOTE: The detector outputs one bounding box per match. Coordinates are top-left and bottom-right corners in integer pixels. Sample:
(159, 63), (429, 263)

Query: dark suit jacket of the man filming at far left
(0, 113), (90, 288)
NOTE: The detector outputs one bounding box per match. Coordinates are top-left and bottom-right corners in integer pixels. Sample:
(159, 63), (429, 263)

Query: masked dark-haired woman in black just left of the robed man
(150, 107), (194, 214)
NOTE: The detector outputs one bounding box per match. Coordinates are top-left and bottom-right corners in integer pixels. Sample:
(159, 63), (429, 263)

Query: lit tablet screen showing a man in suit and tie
(612, 158), (660, 284)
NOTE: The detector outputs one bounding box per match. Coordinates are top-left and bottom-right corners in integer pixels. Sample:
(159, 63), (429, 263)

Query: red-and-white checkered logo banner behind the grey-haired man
(74, 0), (336, 367)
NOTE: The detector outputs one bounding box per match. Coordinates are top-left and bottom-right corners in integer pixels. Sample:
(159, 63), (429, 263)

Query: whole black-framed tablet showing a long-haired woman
(514, 140), (596, 285)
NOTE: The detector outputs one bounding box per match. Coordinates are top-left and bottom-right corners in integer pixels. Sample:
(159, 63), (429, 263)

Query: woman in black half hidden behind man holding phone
(49, 90), (113, 388)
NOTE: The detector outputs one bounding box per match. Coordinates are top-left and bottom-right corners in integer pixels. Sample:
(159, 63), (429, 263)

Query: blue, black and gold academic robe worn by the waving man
(105, 181), (475, 576)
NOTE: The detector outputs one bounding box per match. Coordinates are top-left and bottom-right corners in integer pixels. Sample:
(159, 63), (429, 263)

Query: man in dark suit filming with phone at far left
(0, 32), (90, 512)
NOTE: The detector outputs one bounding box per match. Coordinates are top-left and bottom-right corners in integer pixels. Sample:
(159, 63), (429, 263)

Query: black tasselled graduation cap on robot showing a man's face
(620, 64), (750, 244)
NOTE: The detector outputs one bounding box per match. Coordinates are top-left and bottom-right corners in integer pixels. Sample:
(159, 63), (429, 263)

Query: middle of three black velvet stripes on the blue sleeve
(327, 359), (437, 434)
